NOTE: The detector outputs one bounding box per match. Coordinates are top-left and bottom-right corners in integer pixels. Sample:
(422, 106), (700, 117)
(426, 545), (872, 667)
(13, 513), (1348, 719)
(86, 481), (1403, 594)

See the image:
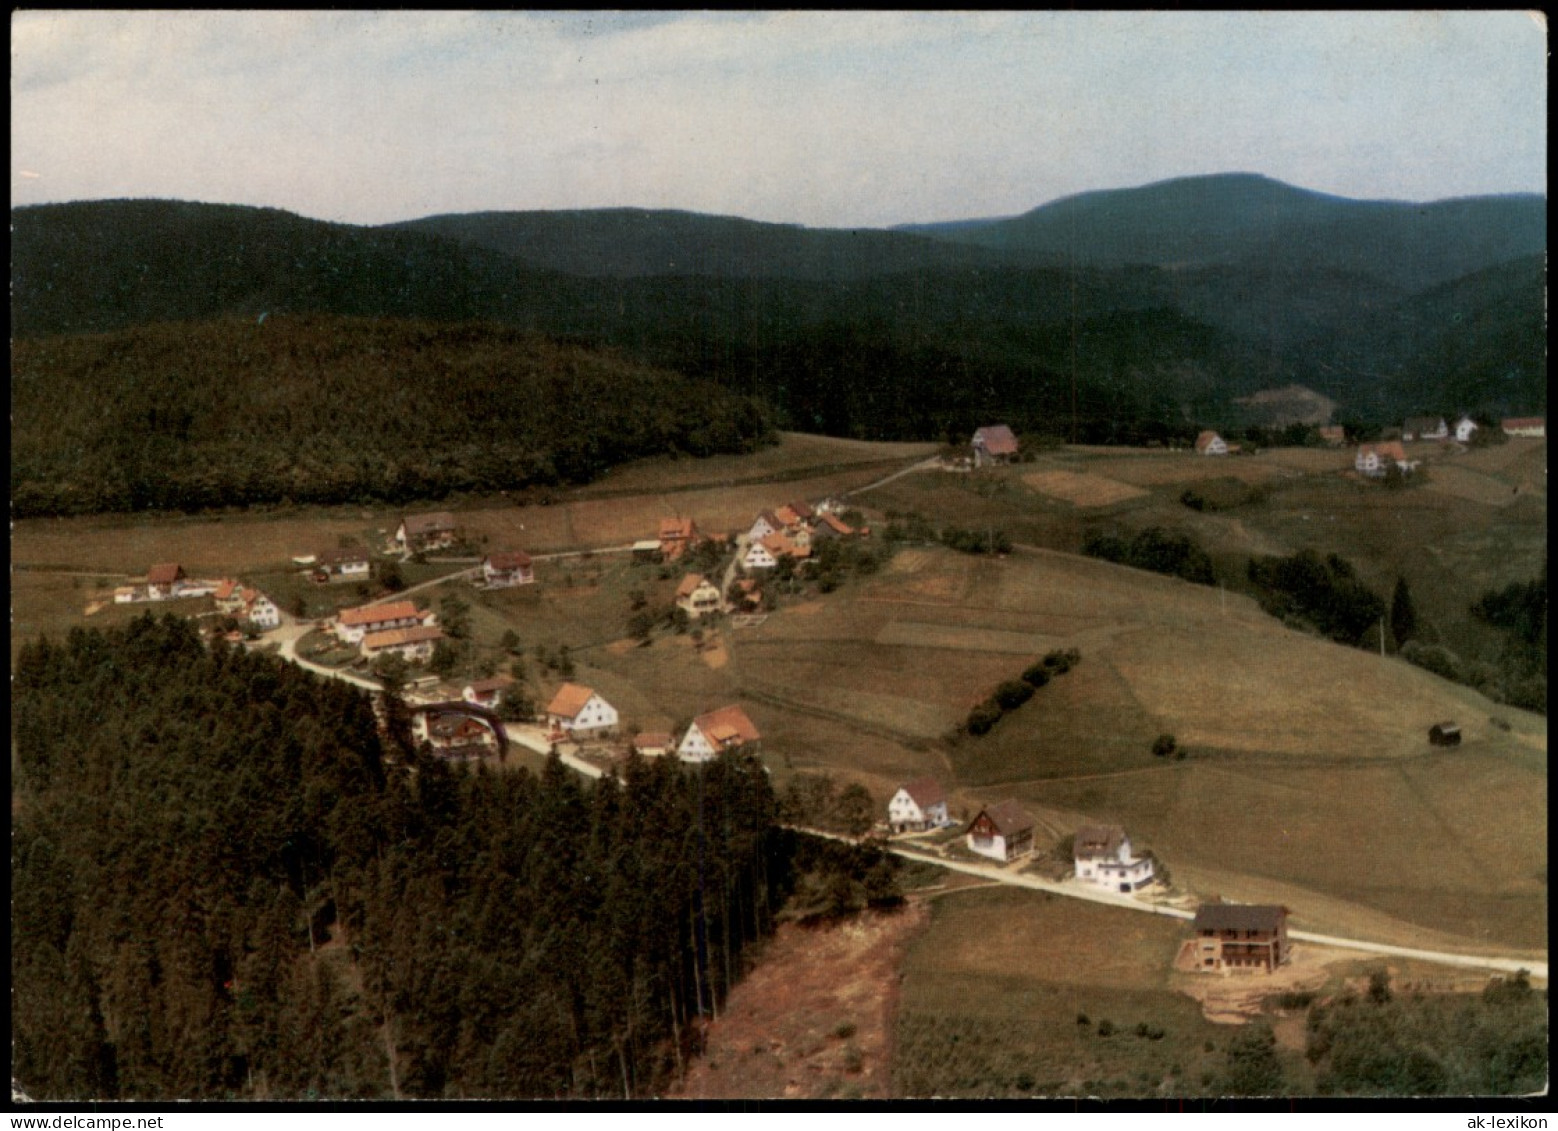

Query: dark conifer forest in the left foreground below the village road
(11, 614), (790, 1100)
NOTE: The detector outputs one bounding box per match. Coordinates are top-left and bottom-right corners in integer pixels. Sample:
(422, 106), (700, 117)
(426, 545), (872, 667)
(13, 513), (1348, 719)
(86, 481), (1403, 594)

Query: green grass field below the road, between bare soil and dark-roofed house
(894, 888), (1265, 1098)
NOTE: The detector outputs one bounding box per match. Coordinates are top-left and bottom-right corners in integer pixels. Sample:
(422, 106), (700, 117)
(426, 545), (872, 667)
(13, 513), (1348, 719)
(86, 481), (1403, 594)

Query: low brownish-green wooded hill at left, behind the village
(11, 316), (770, 517)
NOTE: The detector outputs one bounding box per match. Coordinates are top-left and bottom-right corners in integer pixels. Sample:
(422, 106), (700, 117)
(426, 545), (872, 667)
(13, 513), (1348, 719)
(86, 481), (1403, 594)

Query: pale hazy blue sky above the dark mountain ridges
(11, 11), (1547, 226)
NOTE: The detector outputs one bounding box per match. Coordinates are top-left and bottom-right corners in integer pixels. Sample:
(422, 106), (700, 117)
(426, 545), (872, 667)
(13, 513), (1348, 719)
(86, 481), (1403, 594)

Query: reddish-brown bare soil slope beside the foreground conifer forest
(670, 904), (929, 1100)
